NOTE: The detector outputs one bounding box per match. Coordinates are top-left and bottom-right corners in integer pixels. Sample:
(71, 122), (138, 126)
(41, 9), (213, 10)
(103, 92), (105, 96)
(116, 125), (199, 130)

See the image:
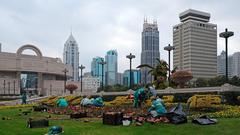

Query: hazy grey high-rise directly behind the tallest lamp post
(217, 51), (233, 78)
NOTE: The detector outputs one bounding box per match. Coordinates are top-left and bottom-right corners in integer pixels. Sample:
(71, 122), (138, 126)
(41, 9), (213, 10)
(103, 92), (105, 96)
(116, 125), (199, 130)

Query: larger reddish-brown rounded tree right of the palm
(171, 70), (193, 88)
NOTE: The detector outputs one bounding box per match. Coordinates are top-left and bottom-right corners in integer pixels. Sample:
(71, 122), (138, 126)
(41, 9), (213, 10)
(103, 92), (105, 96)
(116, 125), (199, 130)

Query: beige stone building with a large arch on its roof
(0, 45), (72, 95)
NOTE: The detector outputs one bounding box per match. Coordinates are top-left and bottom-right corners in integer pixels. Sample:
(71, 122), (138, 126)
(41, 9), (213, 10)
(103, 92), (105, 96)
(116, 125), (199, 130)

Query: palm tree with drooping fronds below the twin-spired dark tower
(137, 58), (168, 89)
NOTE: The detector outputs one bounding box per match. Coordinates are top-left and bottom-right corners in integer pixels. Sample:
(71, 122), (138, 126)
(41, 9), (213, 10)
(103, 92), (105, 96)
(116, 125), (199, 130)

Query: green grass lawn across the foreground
(0, 109), (240, 135)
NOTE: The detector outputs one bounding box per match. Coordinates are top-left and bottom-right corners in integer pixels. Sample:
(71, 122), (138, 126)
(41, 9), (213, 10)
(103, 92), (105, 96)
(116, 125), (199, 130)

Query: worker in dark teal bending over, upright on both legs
(133, 88), (146, 108)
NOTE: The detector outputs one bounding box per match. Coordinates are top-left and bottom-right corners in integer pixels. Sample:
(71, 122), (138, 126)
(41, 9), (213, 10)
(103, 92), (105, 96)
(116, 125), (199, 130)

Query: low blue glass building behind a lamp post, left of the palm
(123, 69), (141, 86)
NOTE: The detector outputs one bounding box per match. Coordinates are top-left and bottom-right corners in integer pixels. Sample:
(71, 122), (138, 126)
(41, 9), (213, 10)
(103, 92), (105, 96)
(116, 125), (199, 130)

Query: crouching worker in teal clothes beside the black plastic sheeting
(148, 97), (167, 117)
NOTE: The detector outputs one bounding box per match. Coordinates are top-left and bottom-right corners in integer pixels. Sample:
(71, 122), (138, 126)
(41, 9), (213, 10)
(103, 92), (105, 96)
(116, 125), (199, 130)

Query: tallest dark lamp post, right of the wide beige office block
(219, 28), (234, 83)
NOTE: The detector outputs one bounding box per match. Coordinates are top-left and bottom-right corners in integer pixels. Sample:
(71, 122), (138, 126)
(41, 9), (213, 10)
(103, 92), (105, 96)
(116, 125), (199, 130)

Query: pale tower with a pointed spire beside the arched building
(63, 33), (79, 81)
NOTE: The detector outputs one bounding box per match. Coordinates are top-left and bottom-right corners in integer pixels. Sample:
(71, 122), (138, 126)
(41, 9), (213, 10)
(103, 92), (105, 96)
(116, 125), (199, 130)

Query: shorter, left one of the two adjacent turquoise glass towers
(91, 57), (105, 83)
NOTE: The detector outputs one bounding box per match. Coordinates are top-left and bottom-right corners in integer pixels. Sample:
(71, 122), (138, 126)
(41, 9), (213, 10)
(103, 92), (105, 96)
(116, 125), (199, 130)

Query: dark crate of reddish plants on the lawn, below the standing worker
(103, 112), (123, 125)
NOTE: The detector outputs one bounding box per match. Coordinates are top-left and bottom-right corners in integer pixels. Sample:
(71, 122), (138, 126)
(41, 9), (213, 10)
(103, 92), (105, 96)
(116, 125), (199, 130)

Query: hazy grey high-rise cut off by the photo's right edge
(232, 52), (240, 77)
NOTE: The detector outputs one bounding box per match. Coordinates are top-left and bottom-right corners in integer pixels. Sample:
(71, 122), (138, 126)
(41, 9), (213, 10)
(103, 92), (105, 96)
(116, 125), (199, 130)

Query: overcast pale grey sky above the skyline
(0, 0), (240, 72)
